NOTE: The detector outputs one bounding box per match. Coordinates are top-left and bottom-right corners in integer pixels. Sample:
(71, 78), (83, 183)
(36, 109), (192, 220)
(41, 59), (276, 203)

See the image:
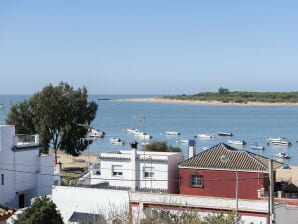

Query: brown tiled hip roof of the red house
(178, 143), (282, 172)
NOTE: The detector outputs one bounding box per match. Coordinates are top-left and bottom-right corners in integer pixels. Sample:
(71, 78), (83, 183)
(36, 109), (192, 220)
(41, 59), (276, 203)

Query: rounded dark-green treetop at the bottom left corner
(16, 196), (63, 224)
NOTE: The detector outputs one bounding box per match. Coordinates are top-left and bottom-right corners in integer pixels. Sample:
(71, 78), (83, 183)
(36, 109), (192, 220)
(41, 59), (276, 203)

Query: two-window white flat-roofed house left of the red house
(79, 148), (183, 193)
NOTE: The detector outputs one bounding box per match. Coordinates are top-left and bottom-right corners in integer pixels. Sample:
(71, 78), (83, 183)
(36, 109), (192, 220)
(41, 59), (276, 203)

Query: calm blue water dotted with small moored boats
(0, 95), (298, 165)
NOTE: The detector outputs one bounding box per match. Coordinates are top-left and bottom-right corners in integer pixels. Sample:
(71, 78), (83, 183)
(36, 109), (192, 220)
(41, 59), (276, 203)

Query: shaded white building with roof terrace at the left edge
(0, 125), (54, 208)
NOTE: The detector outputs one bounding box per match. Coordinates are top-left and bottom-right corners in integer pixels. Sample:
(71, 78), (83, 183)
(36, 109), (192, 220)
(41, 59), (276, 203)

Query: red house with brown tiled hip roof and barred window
(179, 143), (282, 199)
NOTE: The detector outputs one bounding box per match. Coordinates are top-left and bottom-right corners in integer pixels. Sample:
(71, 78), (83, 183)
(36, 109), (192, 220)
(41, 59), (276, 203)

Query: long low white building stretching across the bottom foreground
(52, 186), (298, 224)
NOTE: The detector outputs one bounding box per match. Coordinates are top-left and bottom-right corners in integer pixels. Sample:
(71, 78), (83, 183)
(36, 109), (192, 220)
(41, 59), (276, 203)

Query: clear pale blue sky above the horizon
(0, 0), (298, 94)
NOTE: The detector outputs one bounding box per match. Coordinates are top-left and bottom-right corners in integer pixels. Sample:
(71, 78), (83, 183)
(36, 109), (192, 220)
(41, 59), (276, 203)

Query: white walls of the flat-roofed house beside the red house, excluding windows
(99, 150), (183, 192)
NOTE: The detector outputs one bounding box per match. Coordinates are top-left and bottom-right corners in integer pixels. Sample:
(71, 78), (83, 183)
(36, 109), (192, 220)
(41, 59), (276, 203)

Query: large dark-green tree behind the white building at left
(6, 82), (98, 161)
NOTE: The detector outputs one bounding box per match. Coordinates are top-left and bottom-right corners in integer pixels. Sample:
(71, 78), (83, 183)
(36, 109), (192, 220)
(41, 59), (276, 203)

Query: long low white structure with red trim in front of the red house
(129, 192), (268, 224)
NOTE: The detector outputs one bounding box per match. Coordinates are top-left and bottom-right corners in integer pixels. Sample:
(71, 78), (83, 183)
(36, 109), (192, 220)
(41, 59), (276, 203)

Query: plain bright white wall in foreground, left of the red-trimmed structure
(52, 186), (129, 223)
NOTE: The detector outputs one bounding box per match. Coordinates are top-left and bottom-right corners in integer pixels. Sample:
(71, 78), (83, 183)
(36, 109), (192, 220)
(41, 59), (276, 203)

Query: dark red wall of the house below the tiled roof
(179, 168), (268, 199)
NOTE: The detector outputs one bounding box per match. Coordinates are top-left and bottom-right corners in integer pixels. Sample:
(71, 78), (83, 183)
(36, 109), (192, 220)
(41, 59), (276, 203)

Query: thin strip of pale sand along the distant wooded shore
(113, 97), (298, 106)
